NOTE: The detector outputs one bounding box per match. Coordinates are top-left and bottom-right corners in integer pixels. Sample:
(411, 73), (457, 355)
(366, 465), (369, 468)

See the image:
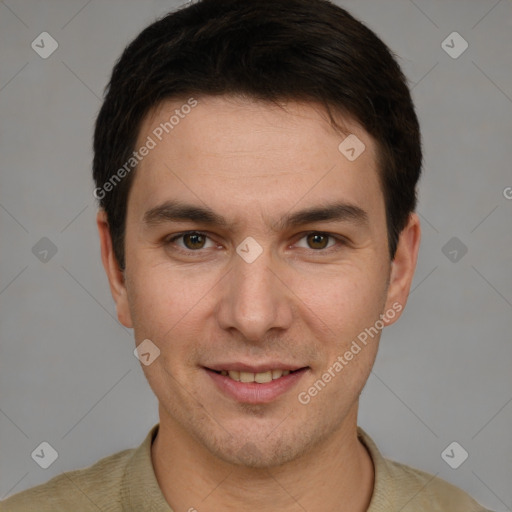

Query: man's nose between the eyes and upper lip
(217, 245), (294, 343)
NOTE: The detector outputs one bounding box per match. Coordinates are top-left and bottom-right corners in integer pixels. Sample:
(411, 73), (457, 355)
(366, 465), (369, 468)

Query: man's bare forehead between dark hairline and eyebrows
(130, 96), (383, 226)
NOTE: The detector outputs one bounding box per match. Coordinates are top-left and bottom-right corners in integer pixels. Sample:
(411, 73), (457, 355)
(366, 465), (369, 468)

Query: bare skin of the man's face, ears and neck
(97, 96), (420, 512)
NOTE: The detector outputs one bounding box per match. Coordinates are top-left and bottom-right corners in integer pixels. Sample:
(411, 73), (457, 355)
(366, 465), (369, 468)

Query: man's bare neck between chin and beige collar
(151, 403), (374, 512)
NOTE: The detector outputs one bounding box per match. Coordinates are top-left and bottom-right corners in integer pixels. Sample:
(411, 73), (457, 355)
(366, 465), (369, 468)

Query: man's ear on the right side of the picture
(383, 213), (421, 325)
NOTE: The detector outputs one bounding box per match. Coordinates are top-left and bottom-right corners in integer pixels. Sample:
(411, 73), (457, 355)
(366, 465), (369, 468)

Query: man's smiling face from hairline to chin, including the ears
(98, 97), (419, 467)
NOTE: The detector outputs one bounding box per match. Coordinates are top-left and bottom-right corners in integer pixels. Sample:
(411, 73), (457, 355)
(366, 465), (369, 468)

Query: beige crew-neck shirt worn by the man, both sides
(0, 424), (494, 512)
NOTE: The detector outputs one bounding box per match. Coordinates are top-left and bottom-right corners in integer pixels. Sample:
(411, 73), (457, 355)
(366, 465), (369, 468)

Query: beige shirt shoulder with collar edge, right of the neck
(358, 427), (490, 512)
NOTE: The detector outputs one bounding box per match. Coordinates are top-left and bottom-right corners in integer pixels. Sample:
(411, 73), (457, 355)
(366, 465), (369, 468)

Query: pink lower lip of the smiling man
(205, 368), (307, 404)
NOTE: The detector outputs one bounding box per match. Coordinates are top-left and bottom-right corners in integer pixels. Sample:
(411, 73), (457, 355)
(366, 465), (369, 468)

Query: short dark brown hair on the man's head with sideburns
(93, 0), (422, 269)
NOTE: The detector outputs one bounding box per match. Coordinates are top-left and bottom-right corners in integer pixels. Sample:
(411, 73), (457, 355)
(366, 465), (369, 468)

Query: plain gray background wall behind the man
(0, 0), (512, 511)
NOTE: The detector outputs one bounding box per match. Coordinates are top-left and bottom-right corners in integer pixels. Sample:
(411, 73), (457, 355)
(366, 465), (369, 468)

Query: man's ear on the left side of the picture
(96, 209), (133, 328)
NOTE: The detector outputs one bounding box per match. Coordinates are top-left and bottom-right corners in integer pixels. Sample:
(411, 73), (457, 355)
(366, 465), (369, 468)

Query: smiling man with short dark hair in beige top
(1, 0), (494, 512)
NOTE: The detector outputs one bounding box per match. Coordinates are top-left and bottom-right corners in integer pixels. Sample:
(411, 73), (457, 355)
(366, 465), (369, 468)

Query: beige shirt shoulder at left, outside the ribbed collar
(0, 449), (135, 512)
